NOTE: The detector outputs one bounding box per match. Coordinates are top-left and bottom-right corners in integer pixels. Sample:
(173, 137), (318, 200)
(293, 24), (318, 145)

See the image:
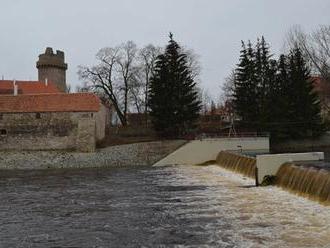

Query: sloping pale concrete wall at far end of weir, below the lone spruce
(154, 137), (269, 166)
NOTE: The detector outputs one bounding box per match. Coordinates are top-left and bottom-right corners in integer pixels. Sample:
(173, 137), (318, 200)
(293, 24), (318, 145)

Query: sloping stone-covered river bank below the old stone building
(0, 140), (186, 169)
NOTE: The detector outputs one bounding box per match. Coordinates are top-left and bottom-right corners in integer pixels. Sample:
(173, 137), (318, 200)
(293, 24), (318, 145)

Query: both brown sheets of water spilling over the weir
(216, 151), (330, 205)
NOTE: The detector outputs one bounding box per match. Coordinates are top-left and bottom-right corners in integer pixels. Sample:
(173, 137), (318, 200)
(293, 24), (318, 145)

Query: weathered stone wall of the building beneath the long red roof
(0, 112), (104, 152)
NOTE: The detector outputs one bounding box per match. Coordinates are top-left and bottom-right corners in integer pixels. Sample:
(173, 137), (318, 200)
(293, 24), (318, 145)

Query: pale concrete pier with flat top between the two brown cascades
(257, 152), (324, 183)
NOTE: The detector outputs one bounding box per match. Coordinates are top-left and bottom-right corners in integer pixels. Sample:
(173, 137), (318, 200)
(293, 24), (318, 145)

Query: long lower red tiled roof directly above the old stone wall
(0, 93), (101, 113)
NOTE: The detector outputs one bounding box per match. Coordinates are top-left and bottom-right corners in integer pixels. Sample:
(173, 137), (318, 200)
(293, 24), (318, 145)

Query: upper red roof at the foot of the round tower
(0, 80), (61, 95)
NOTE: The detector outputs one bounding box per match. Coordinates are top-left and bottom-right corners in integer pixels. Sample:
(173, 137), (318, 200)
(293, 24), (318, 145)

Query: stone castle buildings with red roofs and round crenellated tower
(0, 48), (110, 152)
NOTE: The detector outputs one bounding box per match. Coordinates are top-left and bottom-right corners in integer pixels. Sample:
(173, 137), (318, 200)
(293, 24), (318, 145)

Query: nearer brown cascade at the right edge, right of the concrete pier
(276, 162), (330, 205)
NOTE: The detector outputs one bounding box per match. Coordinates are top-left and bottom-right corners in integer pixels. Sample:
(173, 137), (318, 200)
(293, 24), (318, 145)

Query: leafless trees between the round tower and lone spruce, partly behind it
(78, 41), (204, 126)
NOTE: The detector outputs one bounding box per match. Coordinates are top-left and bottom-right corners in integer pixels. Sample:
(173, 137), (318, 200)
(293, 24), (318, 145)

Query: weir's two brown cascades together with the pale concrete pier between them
(216, 151), (330, 205)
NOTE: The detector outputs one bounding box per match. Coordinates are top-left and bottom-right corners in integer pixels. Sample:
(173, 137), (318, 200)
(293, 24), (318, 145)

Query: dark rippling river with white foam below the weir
(0, 166), (330, 248)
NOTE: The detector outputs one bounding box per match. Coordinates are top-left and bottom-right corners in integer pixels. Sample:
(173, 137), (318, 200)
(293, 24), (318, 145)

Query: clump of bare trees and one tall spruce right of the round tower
(78, 34), (201, 137)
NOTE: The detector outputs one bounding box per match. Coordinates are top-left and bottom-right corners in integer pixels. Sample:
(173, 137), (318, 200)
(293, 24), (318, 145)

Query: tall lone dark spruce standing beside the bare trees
(149, 34), (201, 137)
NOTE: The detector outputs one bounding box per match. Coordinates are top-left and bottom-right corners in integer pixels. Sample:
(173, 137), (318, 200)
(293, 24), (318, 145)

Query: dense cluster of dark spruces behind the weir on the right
(231, 37), (324, 139)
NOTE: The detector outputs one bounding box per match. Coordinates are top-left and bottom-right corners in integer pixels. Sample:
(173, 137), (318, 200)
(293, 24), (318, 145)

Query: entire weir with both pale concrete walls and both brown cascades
(154, 137), (330, 205)
